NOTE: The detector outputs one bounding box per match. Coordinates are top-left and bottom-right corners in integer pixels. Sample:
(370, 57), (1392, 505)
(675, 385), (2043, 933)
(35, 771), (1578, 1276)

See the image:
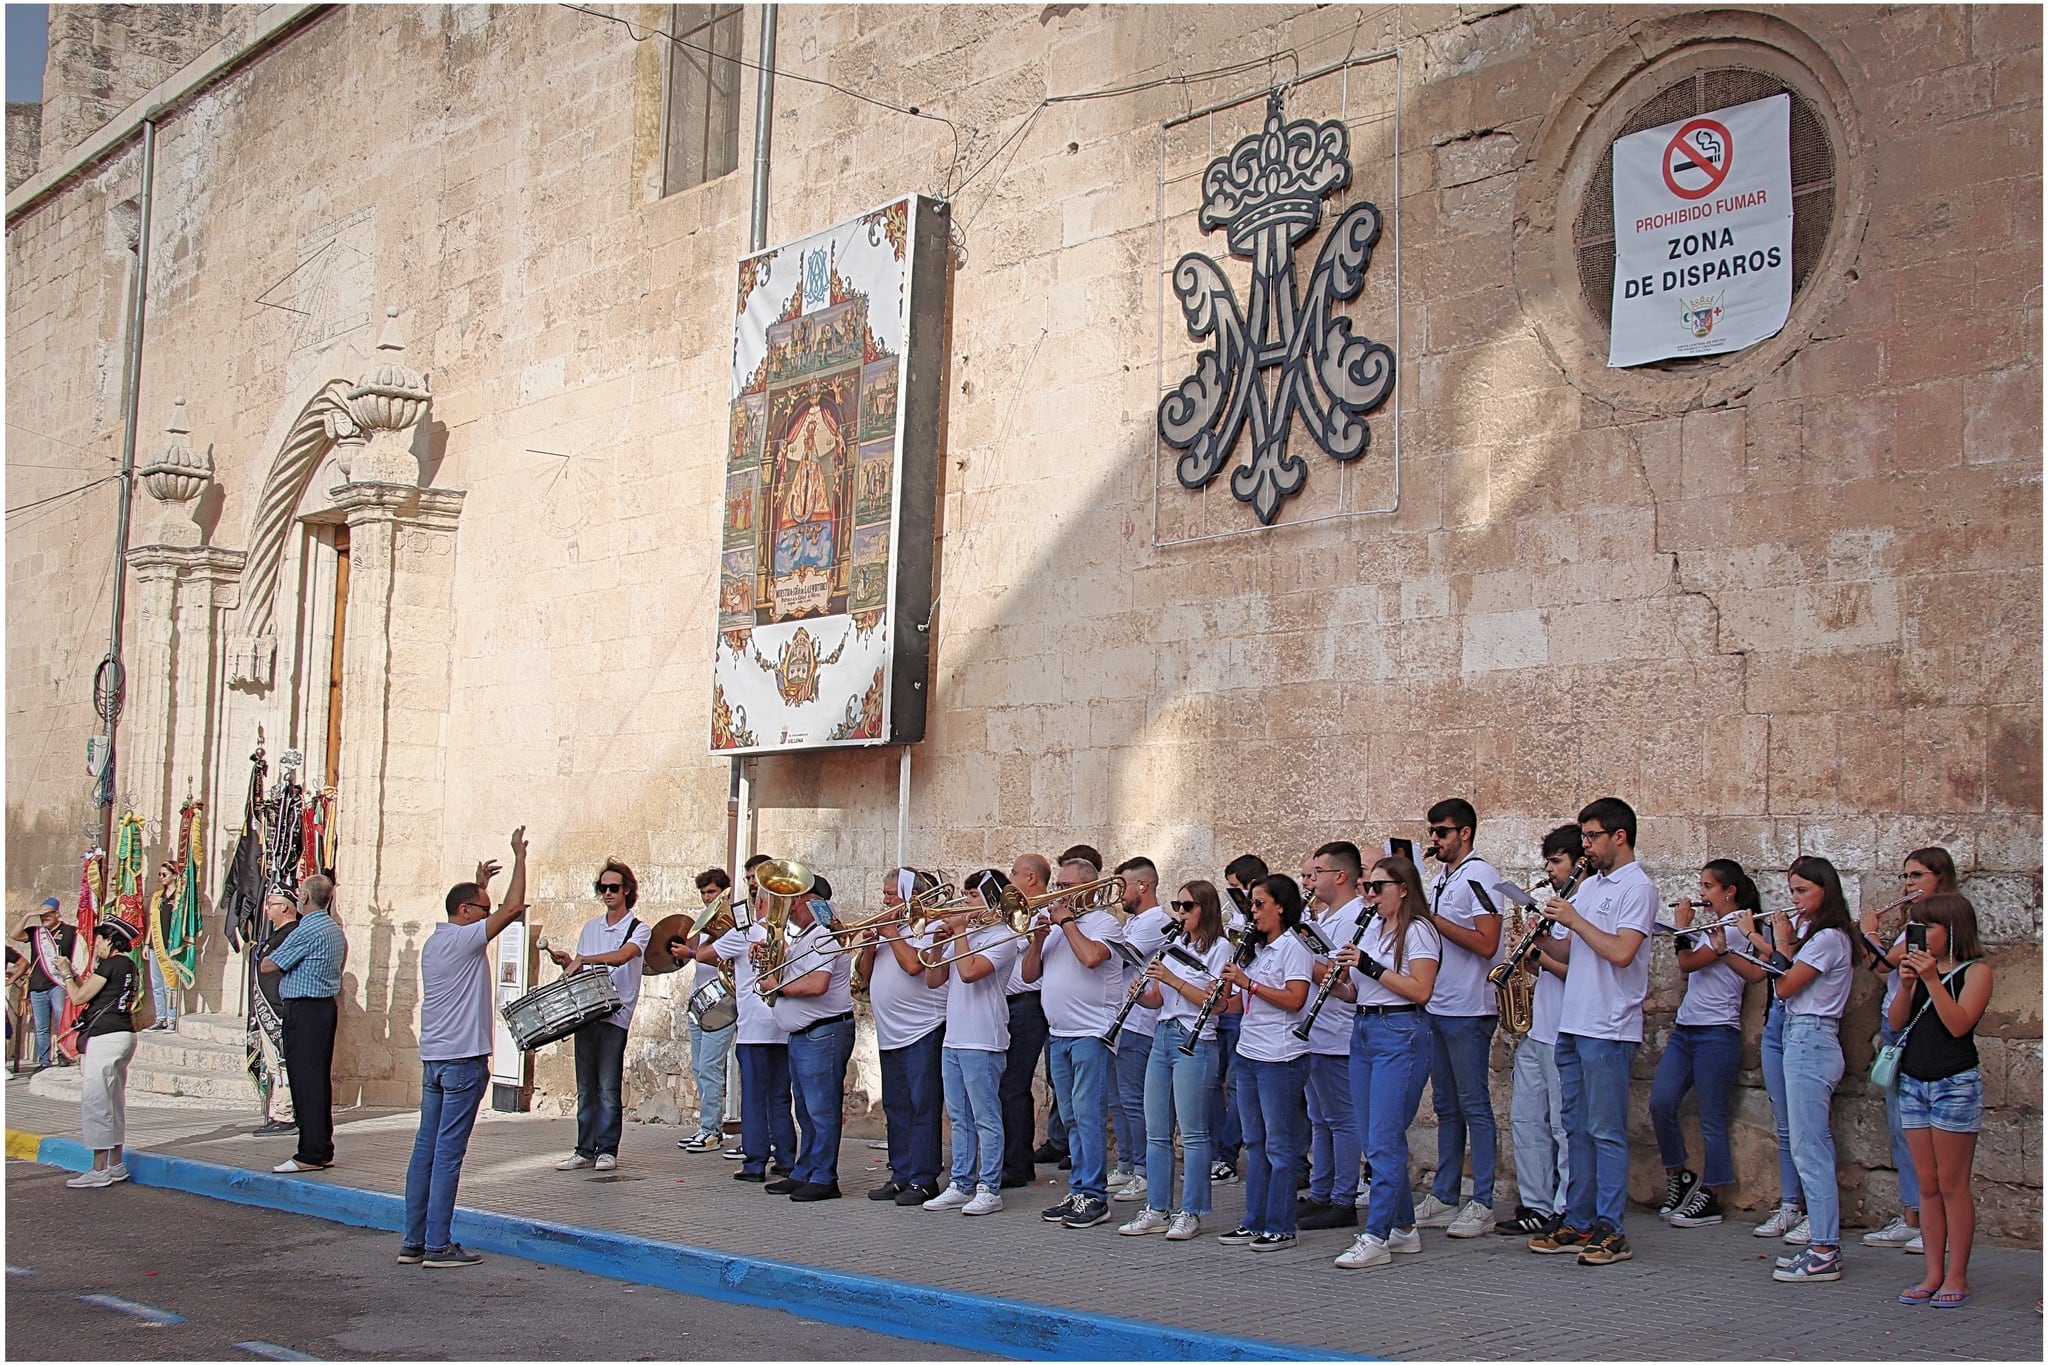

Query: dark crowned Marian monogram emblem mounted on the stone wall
(1159, 90), (1395, 526)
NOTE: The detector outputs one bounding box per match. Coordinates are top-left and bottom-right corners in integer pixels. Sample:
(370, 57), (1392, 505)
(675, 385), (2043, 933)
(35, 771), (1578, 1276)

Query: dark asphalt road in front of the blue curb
(6, 1160), (995, 1361)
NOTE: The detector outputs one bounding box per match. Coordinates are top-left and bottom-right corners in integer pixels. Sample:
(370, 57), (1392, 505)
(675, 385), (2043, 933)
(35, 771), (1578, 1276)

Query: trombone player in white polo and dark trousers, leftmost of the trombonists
(860, 868), (946, 1207)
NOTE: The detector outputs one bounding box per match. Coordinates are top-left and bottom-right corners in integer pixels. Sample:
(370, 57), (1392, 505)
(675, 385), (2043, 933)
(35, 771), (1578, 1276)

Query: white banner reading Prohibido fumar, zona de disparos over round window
(1608, 94), (1792, 366)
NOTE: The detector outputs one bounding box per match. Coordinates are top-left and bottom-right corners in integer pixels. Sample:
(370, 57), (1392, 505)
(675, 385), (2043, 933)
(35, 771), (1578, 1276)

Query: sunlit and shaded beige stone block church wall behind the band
(6, 6), (2042, 1236)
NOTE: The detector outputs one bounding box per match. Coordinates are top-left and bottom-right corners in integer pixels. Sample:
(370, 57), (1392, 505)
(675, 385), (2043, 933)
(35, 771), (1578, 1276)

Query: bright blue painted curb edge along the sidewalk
(37, 1138), (1374, 1361)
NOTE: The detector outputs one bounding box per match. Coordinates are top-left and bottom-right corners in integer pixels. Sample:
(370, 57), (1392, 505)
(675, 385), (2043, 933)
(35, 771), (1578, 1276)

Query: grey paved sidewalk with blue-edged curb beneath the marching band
(6, 1083), (2044, 1361)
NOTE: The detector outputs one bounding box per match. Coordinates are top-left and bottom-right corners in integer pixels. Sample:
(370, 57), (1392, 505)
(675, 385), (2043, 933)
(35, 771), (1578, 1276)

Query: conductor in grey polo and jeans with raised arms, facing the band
(397, 825), (526, 1271)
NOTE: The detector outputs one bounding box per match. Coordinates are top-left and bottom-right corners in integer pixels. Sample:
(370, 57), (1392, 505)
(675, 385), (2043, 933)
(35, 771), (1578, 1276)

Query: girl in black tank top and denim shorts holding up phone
(1890, 892), (1991, 1308)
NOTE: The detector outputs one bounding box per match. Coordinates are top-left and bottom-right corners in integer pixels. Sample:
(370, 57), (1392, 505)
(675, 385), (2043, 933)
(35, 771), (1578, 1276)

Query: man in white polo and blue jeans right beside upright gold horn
(764, 876), (854, 1203)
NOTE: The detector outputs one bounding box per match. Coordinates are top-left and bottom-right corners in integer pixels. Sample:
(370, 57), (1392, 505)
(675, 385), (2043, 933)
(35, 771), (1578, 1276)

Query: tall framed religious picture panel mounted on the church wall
(711, 194), (948, 753)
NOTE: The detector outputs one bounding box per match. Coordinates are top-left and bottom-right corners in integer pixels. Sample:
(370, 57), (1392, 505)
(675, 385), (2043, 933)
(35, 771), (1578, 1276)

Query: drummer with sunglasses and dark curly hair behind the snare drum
(547, 857), (647, 1171)
